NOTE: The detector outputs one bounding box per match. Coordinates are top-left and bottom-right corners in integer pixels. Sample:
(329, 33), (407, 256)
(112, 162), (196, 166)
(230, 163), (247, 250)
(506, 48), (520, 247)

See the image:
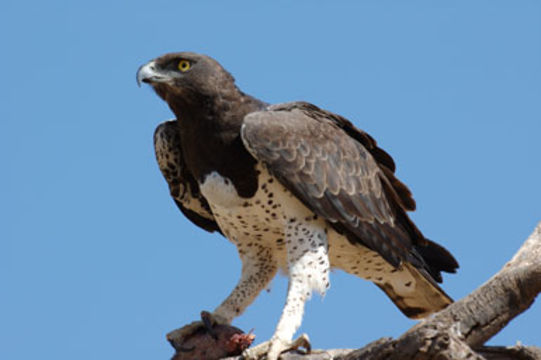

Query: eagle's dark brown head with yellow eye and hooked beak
(137, 52), (238, 105)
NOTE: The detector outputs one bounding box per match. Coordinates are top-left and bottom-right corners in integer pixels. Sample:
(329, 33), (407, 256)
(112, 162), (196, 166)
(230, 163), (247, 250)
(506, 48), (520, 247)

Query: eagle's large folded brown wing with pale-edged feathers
(241, 103), (424, 266)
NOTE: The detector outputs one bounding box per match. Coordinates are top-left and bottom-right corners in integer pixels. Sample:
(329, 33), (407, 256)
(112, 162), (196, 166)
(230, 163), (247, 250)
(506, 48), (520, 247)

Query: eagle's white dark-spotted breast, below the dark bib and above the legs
(200, 165), (325, 271)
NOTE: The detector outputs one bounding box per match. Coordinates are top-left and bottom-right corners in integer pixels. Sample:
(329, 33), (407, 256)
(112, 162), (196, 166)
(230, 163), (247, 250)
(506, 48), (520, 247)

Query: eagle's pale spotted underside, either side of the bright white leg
(200, 166), (399, 283)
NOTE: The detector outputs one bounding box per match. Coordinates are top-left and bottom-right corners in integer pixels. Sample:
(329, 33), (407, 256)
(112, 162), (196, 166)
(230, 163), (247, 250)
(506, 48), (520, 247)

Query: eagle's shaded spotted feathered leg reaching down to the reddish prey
(212, 244), (277, 324)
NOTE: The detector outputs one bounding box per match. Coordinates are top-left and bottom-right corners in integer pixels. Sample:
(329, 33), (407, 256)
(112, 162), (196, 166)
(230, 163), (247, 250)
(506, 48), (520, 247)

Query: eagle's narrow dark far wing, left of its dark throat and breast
(154, 120), (221, 232)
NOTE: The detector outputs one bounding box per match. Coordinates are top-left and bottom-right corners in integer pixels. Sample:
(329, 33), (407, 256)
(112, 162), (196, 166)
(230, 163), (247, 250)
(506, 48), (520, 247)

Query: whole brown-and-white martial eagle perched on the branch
(137, 52), (458, 360)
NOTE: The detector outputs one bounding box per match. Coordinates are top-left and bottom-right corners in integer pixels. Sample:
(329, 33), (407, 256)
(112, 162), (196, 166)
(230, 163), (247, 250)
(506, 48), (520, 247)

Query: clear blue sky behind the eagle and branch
(0, 0), (541, 360)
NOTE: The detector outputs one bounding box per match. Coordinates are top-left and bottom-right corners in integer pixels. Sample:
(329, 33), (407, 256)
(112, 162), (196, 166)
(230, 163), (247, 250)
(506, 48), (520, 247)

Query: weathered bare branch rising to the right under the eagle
(224, 222), (541, 360)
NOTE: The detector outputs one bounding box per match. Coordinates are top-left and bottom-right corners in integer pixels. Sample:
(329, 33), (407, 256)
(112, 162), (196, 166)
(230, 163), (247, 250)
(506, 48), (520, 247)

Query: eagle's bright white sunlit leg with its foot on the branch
(243, 219), (330, 360)
